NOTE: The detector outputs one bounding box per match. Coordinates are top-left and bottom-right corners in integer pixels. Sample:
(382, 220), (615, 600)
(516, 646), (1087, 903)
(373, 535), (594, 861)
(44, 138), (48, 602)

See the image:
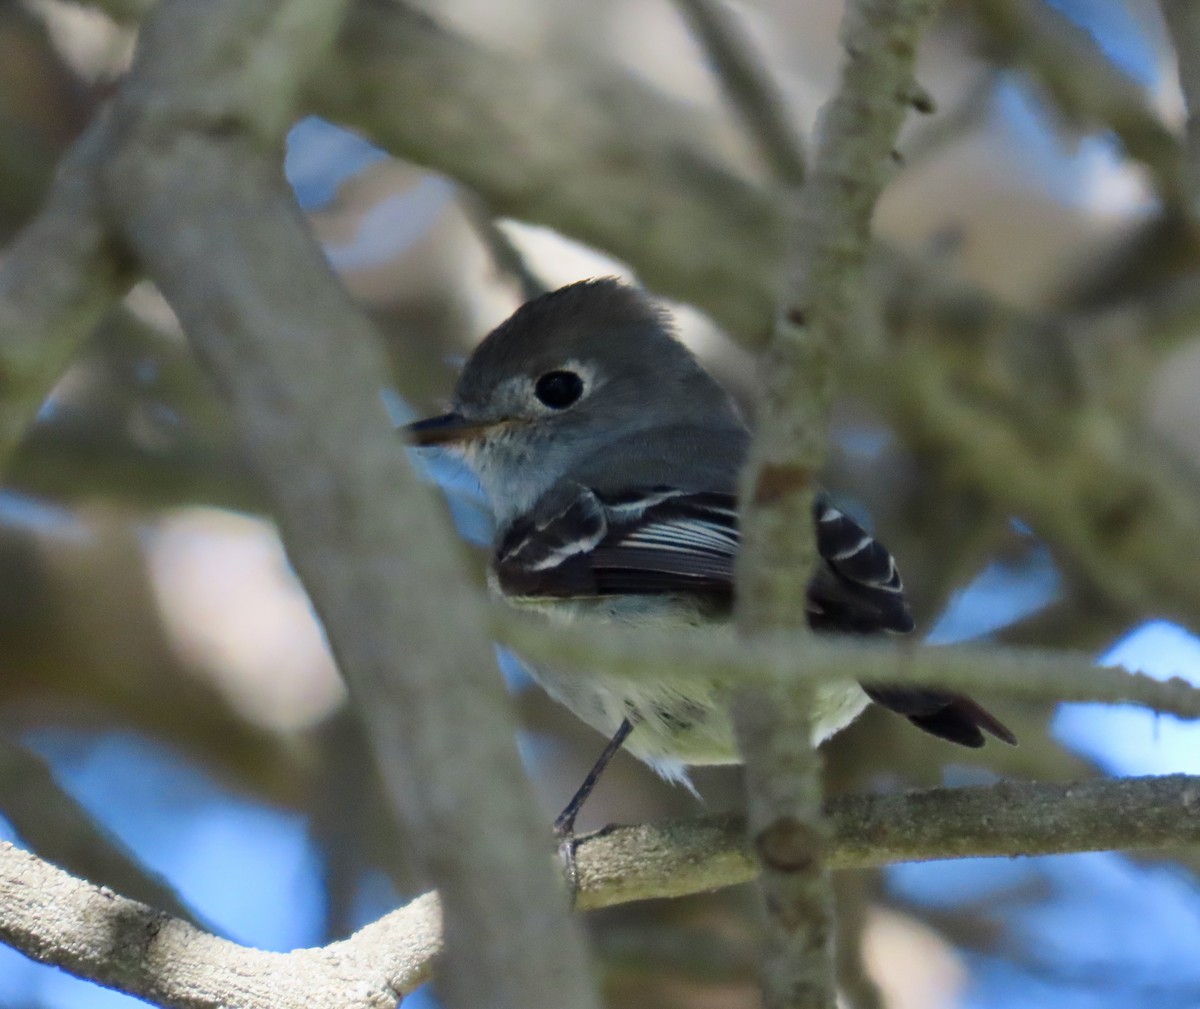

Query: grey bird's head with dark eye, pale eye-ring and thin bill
(407, 280), (740, 518)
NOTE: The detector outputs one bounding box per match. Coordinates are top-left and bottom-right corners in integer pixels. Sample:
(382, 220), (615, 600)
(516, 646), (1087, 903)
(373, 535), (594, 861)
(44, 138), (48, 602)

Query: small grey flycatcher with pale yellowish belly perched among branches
(407, 277), (1016, 836)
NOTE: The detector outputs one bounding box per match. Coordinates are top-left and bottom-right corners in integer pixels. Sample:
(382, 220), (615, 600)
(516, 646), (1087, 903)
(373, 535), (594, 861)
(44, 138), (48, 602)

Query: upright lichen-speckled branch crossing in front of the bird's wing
(733, 0), (935, 1009)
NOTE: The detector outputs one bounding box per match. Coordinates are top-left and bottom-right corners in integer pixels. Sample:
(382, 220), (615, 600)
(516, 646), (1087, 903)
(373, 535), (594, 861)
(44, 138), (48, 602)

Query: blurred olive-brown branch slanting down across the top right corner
(968, 0), (1184, 204)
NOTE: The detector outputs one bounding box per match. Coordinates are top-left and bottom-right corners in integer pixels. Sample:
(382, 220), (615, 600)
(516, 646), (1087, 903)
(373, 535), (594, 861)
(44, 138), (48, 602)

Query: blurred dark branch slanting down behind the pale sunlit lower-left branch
(0, 738), (206, 927)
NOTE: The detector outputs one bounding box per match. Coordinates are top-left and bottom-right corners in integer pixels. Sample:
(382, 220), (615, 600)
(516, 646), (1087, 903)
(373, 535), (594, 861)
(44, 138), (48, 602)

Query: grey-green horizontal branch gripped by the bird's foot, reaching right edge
(568, 775), (1200, 908)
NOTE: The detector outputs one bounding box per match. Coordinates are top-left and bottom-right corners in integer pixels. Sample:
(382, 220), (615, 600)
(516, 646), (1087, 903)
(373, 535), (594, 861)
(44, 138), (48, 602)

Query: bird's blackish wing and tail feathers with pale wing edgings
(492, 484), (1015, 746)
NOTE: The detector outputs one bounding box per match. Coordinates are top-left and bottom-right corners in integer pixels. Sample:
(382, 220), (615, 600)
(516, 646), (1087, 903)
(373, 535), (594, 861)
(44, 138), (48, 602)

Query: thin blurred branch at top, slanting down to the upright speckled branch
(676, 0), (804, 186)
